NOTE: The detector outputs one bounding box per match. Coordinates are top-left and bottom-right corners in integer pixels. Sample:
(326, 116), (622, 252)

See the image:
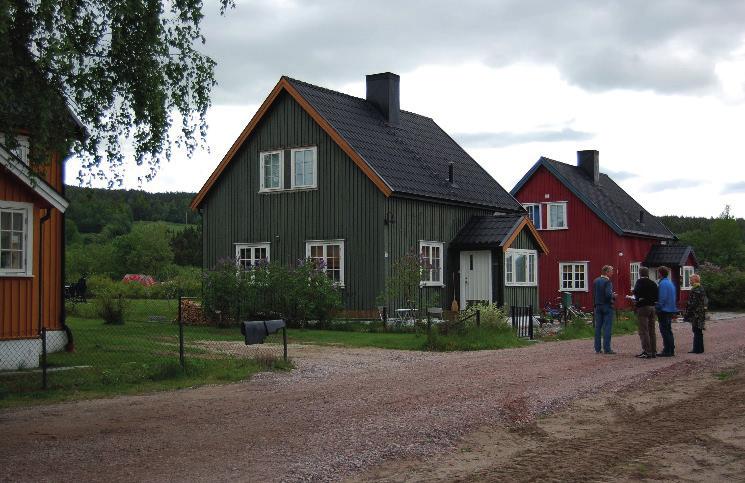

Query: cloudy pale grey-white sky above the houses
(68, 0), (745, 216)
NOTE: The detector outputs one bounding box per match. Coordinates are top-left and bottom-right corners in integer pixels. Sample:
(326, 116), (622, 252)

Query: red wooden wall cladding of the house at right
(515, 166), (658, 309)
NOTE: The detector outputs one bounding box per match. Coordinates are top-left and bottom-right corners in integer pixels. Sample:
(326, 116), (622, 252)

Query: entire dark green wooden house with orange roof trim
(191, 73), (547, 314)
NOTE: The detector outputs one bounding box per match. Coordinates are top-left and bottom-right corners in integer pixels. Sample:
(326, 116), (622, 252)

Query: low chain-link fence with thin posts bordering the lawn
(0, 297), (287, 400)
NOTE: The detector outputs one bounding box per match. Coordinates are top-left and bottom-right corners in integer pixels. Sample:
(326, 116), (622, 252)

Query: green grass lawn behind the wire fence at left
(0, 314), (291, 408)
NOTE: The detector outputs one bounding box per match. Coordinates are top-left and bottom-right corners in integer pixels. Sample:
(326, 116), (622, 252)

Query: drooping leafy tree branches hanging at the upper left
(0, 0), (233, 186)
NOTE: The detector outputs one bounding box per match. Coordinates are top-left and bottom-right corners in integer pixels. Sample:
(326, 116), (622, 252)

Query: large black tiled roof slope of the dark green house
(286, 78), (523, 212)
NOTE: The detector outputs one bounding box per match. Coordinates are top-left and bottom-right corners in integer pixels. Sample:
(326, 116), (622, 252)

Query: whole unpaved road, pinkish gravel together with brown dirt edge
(0, 318), (745, 481)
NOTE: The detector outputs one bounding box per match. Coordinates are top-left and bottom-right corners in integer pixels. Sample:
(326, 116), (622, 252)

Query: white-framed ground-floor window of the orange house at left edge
(0, 201), (33, 277)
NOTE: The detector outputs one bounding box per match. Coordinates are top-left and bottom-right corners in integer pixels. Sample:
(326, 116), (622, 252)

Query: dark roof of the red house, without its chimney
(511, 157), (677, 240)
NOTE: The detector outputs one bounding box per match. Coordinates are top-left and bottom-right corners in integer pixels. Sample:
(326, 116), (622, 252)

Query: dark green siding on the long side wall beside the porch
(378, 199), (493, 309)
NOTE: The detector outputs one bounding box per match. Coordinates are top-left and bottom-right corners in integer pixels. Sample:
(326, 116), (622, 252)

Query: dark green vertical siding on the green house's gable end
(202, 93), (385, 310)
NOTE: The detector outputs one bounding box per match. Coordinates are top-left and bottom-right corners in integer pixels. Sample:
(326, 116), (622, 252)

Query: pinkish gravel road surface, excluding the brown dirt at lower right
(0, 318), (745, 481)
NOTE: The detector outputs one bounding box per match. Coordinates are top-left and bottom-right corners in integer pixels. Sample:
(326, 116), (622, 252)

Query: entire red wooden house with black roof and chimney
(511, 150), (698, 308)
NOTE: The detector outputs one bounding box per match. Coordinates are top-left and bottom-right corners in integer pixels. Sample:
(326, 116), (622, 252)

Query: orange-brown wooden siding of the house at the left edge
(0, 157), (64, 340)
